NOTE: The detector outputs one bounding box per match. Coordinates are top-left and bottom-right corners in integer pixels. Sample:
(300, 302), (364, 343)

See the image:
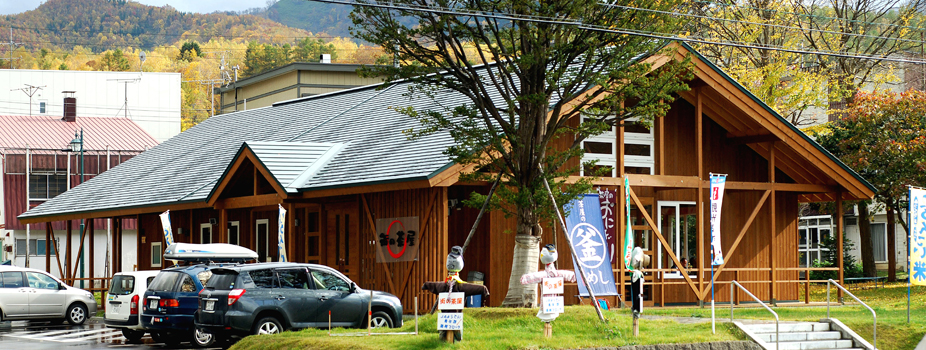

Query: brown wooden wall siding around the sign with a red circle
(358, 188), (450, 312)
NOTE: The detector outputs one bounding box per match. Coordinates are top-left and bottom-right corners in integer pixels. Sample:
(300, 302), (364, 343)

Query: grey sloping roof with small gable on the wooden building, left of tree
(20, 80), (460, 218)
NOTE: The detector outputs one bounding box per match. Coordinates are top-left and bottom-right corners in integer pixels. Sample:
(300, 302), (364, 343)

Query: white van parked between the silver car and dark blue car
(103, 270), (161, 342)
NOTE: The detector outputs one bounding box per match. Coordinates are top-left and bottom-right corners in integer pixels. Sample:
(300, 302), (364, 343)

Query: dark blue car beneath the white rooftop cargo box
(141, 264), (234, 346)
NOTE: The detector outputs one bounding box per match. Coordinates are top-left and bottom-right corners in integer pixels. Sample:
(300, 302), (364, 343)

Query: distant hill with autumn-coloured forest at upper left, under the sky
(0, 0), (311, 52)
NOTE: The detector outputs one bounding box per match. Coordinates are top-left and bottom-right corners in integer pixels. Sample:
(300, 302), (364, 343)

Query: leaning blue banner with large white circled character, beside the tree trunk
(566, 194), (617, 296)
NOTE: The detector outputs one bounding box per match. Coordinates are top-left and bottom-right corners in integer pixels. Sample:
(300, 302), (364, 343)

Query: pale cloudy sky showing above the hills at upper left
(0, 0), (267, 15)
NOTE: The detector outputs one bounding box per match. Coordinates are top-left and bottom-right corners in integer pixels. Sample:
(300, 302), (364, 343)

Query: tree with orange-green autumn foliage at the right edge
(815, 90), (926, 281)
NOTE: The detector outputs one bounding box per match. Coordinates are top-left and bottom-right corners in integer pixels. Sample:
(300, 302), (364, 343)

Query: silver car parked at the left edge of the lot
(0, 266), (96, 325)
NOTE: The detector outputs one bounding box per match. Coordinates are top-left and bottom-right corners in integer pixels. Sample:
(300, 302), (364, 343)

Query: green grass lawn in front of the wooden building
(232, 284), (926, 350)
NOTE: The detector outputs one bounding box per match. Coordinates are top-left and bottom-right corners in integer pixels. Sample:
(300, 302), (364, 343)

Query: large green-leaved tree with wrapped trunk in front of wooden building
(351, 0), (688, 307)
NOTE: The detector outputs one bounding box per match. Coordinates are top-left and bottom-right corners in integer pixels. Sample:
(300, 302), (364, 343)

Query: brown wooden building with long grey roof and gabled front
(19, 45), (873, 311)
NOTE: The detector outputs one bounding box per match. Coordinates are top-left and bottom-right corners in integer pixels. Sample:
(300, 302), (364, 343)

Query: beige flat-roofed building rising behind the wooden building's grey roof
(215, 63), (383, 114)
